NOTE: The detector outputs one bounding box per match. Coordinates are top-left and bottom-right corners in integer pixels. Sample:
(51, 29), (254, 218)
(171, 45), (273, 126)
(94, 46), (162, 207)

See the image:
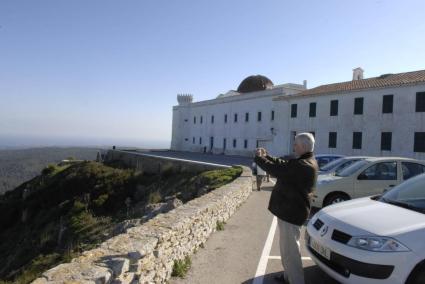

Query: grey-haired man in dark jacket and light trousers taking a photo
(254, 133), (319, 284)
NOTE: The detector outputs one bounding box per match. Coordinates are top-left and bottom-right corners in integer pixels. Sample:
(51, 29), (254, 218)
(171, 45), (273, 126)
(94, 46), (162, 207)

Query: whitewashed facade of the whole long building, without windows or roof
(171, 71), (425, 159)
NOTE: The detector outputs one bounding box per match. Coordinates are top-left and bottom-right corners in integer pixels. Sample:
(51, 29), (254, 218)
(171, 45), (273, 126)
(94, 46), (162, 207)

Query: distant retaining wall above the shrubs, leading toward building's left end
(105, 150), (229, 174)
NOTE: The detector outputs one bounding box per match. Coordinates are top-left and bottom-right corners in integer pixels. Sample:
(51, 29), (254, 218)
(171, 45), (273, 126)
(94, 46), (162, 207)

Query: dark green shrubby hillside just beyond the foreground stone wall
(0, 162), (241, 283)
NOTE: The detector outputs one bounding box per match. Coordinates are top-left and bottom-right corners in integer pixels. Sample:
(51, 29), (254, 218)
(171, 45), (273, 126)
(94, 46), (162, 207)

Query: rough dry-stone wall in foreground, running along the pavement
(33, 167), (252, 284)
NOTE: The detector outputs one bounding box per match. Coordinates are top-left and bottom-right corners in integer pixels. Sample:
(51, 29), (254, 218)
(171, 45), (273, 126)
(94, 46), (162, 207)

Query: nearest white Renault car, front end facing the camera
(305, 174), (425, 284)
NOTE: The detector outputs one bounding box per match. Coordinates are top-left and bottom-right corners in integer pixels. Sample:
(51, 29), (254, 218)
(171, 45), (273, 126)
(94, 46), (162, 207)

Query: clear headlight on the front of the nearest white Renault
(347, 237), (410, 252)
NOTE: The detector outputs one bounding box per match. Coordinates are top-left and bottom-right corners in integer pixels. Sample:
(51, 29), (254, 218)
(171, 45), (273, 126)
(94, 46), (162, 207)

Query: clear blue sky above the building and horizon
(0, 0), (425, 149)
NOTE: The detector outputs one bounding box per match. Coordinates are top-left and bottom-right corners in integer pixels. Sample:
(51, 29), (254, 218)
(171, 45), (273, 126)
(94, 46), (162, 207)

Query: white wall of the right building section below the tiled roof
(285, 84), (425, 159)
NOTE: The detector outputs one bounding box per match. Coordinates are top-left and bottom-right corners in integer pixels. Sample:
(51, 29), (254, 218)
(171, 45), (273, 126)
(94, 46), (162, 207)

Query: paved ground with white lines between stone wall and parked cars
(170, 183), (338, 284)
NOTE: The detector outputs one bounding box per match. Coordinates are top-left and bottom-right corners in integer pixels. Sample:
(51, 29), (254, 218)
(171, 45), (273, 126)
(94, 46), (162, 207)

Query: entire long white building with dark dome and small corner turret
(171, 68), (425, 159)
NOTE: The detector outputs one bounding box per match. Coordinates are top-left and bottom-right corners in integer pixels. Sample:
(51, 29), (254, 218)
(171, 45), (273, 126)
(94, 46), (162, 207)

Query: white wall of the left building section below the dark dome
(172, 88), (301, 156)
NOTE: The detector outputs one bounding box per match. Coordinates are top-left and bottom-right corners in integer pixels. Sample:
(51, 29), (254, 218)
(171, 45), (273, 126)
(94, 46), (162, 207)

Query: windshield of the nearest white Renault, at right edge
(379, 174), (425, 214)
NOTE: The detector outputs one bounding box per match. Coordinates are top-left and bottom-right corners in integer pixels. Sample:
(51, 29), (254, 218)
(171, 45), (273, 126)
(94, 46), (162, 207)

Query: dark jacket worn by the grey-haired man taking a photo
(254, 152), (319, 226)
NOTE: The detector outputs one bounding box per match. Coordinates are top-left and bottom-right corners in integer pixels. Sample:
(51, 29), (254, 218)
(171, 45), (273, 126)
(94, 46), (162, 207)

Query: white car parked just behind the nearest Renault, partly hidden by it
(312, 157), (425, 208)
